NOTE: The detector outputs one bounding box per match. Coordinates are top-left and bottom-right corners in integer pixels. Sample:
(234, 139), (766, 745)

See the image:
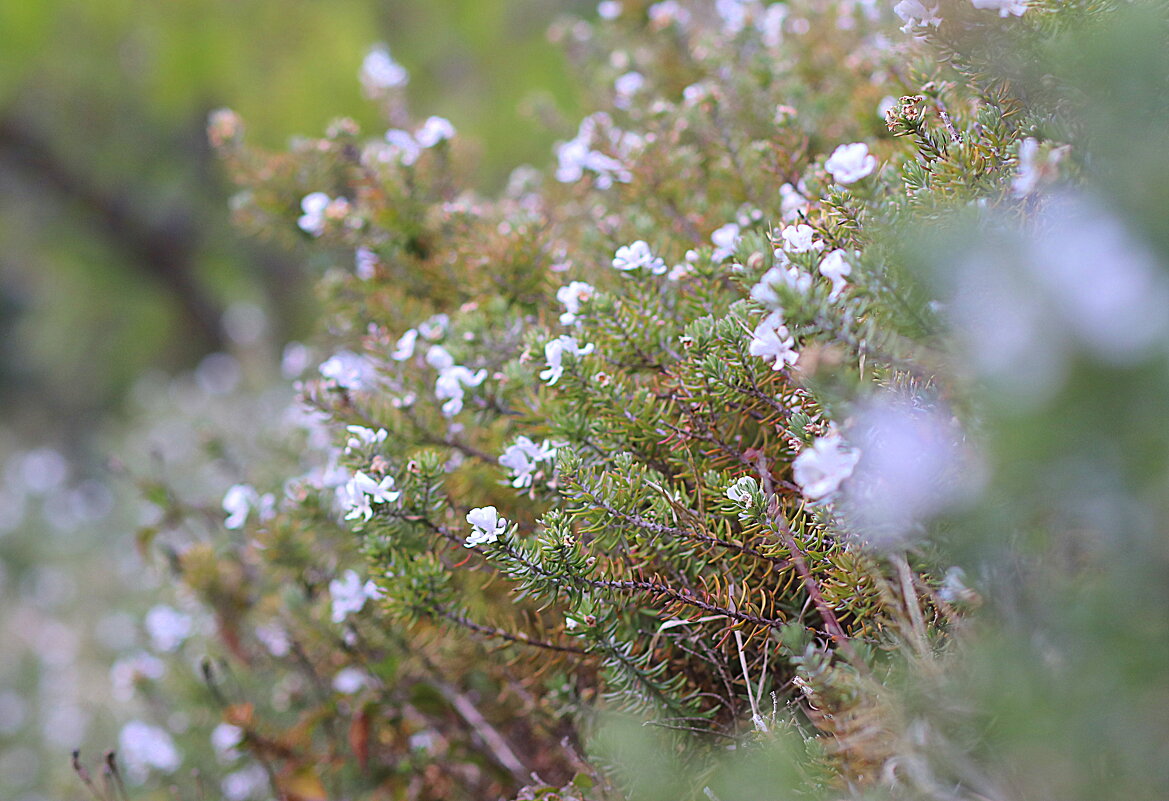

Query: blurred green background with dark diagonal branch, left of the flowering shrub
(0, 0), (584, 801)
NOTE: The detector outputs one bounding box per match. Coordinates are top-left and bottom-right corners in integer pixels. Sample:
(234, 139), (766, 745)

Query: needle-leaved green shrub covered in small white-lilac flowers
(113, 0), (1169, 799)
